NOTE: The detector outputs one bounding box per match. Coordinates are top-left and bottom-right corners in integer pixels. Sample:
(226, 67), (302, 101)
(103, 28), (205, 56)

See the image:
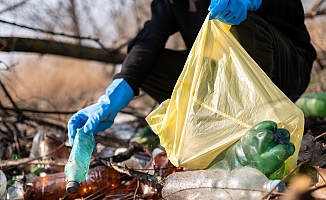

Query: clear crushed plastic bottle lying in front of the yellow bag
(162, 167), (286, 200)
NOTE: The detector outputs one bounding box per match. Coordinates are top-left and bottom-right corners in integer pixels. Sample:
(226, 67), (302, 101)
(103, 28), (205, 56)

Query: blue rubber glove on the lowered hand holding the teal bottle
(68, 78), (134, 146)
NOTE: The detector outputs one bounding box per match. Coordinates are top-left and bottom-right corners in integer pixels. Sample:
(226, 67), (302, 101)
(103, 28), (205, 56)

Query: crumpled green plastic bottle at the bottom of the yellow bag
(207, 121), (295, 179)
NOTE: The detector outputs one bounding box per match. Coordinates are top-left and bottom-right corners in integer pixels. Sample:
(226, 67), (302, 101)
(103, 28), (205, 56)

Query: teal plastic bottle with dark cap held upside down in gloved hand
(65, 128), (95, 194)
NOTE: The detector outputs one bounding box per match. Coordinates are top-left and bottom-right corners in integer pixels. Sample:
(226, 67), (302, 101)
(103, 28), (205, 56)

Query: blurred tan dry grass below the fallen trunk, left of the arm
(1, 55), (112, 110)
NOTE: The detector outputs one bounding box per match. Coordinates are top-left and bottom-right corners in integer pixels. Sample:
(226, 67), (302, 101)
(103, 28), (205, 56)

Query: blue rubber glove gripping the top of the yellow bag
(208, 0), (262, 25)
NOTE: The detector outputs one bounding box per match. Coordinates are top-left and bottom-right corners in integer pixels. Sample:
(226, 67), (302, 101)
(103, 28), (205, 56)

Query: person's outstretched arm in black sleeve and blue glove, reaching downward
(68, 0), (175, 145)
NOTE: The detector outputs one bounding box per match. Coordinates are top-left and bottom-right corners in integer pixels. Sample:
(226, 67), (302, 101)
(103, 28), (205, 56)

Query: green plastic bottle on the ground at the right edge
(295, 93), (326, 118)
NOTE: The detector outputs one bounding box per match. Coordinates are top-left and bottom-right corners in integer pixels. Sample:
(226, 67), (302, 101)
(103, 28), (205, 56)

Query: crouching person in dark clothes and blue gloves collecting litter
(68, 0), (316, 145)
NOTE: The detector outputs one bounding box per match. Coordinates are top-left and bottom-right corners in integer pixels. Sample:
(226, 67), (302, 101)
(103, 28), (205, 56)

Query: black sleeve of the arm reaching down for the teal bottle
(114, 0), (177, 95)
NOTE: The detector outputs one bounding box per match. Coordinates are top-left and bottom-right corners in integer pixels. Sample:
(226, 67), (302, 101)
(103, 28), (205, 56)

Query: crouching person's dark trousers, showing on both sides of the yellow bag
(141, 13), (311, 103)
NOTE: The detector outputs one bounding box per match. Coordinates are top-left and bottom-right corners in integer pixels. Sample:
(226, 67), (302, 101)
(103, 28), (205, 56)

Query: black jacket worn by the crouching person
(114, 0), (316, 95)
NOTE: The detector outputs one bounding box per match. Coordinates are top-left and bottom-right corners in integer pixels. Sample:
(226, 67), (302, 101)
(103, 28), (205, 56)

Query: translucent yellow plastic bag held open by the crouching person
(146, 14), (304, 177)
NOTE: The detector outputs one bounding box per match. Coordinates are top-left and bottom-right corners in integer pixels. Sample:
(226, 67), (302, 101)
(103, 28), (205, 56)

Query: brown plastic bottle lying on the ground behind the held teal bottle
(24, 165), (121, 200)
